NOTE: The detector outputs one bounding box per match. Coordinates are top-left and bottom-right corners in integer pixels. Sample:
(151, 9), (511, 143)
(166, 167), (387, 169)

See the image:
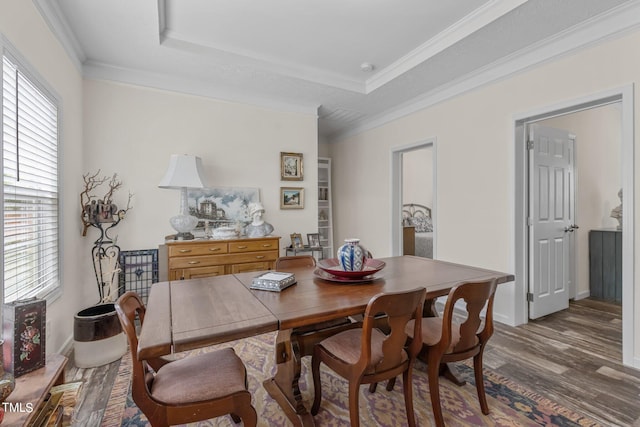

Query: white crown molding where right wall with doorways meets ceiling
(329, 2), (640, 142)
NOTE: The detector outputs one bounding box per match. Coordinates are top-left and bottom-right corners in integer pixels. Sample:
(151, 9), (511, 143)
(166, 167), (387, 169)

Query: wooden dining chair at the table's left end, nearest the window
(115, 291), (257, 427)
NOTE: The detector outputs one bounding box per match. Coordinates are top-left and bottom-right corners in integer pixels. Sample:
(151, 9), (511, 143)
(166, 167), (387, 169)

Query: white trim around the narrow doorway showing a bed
(389, 137), (438, 259)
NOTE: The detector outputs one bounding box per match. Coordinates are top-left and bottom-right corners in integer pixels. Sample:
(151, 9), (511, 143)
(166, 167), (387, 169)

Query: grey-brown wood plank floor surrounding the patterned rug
(66, 299), (640, 426)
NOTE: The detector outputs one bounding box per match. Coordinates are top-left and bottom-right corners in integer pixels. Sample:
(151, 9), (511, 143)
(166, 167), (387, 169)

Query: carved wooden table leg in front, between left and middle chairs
(263, 329), (314, 426)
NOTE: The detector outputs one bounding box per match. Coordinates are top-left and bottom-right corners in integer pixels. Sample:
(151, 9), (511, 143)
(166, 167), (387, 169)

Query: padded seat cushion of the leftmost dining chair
(151, 348), (246, 405)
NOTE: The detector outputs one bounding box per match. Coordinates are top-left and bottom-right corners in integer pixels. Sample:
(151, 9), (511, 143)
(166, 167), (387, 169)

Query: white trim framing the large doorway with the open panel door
(512, 83), (640, 368)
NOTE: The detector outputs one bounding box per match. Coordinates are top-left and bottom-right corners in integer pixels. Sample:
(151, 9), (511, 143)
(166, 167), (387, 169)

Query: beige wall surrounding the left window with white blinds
(0, 0), (85, 353)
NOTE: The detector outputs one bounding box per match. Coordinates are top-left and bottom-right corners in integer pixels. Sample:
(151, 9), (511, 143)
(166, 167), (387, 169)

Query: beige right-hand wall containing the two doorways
(331, 32), (640, 360)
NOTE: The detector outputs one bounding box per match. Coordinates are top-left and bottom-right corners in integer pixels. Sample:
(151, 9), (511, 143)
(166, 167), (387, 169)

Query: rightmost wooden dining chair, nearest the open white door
(404, 279), (497, 426)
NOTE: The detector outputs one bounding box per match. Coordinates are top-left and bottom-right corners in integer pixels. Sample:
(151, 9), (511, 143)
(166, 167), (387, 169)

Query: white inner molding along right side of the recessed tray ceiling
(366, 0), (527, 93)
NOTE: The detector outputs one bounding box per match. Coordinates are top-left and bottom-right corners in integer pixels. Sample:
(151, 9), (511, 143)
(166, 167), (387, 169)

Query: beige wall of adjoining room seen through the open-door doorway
(540, 104), (622, 297)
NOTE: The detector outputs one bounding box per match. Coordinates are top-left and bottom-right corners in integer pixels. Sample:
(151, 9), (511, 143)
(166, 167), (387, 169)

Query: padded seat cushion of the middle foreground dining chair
(319, 328), (408, 374)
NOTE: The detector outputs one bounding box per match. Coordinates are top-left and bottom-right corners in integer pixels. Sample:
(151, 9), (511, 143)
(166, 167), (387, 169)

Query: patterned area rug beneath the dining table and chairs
(102, 333), (599, 427)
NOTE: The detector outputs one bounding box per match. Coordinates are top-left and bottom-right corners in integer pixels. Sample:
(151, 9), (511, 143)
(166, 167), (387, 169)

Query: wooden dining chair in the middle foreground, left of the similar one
(311, 288), (426, 427)
